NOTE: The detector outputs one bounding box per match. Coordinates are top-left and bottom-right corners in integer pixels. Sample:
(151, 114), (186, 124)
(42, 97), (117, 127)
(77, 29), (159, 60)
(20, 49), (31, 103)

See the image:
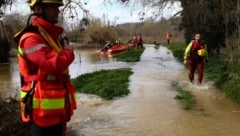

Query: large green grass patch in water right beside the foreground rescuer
(72, 68), (133, 100)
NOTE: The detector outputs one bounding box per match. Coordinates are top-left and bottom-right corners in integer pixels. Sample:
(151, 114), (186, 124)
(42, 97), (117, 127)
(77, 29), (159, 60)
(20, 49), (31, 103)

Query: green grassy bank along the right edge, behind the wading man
(167, 44), (240, 104)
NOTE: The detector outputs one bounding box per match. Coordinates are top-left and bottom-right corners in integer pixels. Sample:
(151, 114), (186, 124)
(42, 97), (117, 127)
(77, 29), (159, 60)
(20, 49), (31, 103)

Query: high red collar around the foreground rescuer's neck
(32, 16), (63, 40)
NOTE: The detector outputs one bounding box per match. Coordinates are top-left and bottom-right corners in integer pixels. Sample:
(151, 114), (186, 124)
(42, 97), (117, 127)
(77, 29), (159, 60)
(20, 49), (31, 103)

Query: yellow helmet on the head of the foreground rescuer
(27, 0), (63, 9)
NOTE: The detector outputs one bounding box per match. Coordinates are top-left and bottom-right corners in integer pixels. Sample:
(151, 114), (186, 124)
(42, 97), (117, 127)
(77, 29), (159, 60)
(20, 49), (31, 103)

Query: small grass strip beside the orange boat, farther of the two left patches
(115, 48), (144, 62)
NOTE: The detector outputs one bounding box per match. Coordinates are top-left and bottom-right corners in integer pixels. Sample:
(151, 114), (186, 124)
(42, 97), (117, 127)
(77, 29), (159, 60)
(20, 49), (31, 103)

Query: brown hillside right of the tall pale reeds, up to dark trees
(116, 17), (184, 44)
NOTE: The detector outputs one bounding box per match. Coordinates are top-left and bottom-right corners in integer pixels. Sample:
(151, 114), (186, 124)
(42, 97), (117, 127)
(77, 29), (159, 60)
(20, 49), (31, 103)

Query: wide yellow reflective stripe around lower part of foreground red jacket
(41, 98), (65, 110)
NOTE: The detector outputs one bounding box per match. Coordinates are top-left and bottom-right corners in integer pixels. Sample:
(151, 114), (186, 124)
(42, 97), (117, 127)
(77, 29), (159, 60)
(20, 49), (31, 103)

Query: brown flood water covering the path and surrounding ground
(0, 45), (240, 136)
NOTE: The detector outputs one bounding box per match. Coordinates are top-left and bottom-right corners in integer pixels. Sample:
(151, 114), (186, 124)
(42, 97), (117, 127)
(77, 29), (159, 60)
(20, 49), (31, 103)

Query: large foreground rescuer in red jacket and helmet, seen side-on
(15, 0), (76, 136)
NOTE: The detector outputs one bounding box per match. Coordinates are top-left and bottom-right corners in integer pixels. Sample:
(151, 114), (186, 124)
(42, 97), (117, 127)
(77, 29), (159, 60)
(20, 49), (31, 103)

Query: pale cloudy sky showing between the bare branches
(3, 0), (181, 24)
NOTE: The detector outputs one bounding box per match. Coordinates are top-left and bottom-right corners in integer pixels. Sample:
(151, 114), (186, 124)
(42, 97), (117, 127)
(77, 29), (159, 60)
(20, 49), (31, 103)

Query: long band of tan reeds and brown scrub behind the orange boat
(68, 18), (184, 46)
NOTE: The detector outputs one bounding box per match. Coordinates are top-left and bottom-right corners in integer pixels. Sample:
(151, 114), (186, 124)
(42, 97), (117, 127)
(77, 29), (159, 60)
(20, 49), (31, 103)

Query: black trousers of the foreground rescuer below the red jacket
(30, 122), (63, 136)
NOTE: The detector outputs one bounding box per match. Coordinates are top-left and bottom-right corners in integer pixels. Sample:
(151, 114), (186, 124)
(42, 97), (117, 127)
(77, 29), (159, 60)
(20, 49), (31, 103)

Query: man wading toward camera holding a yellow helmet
(184, 33), (208, 85)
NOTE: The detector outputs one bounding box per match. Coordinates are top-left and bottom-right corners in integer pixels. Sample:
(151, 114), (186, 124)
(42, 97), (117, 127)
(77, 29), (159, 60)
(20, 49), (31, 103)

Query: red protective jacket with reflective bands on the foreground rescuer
(15, 17), (76, 127)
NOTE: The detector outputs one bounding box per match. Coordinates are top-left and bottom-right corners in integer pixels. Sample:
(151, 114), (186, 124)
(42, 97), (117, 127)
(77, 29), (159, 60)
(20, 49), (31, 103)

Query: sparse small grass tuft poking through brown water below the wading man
(172, 82), (196, 110)
